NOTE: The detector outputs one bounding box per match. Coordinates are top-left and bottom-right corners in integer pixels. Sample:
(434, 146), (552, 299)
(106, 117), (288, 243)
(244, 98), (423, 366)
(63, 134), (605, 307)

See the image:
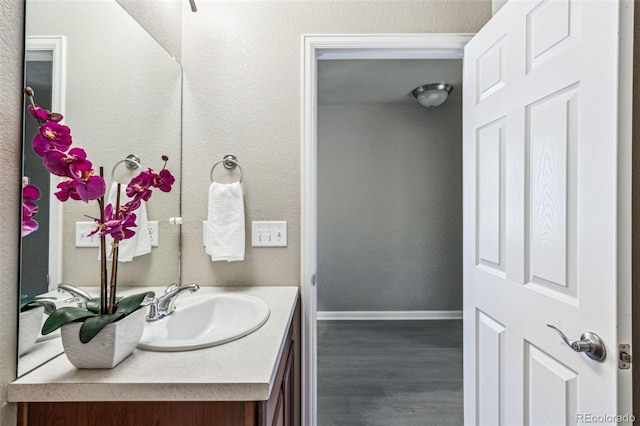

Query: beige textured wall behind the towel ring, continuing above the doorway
(182, 0), (491, 285)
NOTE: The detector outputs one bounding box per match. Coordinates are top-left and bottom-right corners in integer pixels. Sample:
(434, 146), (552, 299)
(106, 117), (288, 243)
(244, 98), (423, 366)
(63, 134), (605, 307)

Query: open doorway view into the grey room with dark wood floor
(317, 59), (463, 426)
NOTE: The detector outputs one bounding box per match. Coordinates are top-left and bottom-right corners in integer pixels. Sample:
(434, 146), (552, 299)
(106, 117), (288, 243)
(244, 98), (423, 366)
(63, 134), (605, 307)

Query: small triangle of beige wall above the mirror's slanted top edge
(116, 0), (184, 61)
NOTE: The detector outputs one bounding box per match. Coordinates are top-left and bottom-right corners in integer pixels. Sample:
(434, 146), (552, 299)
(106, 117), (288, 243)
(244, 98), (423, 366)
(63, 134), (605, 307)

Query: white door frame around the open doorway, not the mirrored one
(300, 33), (473, 426)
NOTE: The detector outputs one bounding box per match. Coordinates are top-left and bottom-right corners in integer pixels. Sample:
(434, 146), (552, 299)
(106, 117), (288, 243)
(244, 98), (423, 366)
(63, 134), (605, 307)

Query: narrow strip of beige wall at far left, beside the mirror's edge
(0, 0), (24, 426)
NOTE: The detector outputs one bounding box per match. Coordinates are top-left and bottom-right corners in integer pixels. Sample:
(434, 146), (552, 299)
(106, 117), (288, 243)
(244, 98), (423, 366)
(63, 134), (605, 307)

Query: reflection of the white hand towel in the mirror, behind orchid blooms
(98, 183), (151, 262)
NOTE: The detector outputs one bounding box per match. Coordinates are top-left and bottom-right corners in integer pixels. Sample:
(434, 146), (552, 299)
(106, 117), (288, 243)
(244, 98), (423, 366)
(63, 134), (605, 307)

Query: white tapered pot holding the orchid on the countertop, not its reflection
(61, 307), (147, 368)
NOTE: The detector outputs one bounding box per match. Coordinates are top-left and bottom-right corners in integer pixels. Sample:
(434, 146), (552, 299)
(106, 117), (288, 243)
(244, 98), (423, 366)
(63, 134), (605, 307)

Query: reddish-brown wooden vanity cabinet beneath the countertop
(18, 305), (300, 426)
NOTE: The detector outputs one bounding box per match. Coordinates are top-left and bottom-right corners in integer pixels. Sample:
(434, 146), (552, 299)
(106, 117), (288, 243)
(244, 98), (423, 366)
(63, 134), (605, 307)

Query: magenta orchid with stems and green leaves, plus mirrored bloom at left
(22, 87), (175, 362)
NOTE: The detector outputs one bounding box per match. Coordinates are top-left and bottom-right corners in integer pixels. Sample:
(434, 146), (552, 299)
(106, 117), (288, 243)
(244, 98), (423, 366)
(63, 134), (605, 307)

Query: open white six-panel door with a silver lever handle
(463, 0), (631, 426)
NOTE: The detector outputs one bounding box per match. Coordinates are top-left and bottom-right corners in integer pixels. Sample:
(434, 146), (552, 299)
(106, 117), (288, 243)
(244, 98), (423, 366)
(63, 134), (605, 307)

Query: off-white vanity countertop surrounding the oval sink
(8, 287), (298, 402)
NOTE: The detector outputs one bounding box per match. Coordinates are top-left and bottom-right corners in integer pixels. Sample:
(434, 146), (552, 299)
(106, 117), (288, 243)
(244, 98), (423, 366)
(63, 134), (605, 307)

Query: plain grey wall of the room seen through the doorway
(318, 103), (462, 311)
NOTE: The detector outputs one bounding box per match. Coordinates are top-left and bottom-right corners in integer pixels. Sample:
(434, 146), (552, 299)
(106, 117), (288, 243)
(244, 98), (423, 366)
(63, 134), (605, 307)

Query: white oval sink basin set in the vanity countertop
(138, 293), (269, 352)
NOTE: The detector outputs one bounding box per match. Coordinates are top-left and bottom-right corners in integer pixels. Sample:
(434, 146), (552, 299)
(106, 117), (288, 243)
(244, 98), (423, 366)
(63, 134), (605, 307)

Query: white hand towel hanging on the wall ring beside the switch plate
(205, 182), (245, 262)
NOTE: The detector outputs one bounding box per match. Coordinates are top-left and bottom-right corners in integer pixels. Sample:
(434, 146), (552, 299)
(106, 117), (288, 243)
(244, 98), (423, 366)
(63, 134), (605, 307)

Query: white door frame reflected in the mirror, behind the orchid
(25, 35), (67, 291)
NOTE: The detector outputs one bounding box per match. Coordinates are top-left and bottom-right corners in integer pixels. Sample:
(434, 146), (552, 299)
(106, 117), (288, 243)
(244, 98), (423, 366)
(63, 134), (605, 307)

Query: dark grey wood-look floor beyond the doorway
(318, 320), (463, 426)
